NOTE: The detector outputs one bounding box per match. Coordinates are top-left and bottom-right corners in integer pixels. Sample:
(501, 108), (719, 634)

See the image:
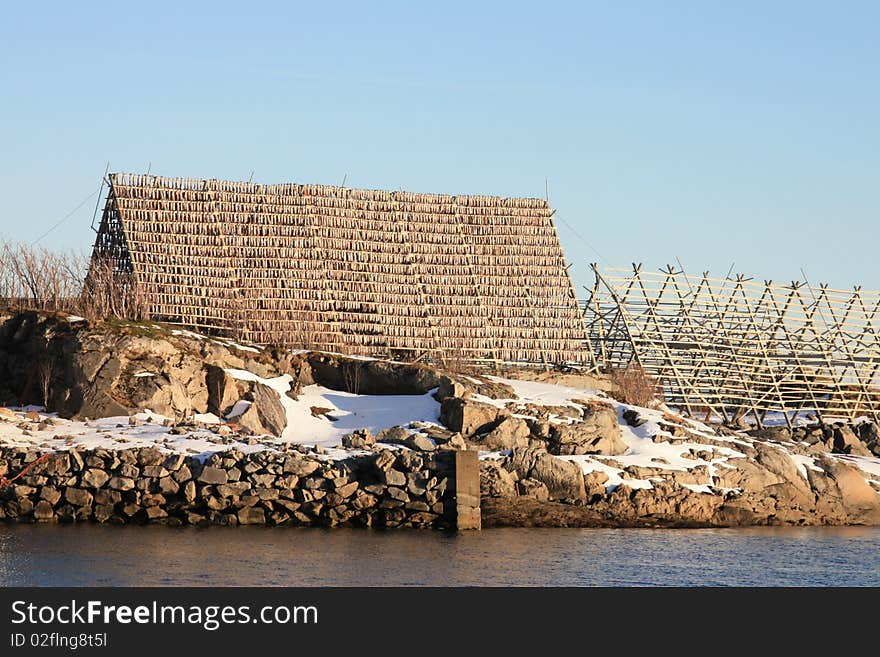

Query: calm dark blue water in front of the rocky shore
(0, 525), (880, 586)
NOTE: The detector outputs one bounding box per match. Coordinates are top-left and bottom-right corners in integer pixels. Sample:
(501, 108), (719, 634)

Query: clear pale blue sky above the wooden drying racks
(0, 1), (880, 289)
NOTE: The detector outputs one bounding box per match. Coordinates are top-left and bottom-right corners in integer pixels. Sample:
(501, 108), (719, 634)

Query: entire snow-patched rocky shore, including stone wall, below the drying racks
(0, 313), (880, 528)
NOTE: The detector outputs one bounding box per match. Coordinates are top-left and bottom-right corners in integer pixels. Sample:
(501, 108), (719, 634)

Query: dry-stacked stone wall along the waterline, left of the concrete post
(0, 445), (457, 529)
